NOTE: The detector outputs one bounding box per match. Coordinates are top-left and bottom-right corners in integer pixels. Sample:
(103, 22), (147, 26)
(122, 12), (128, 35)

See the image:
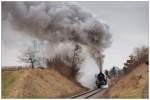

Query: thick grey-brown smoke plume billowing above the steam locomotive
(2, 2), (111, 89)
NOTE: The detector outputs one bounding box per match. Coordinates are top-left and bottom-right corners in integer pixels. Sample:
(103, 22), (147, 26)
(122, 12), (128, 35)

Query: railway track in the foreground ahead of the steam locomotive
(71, 89), (103, 99)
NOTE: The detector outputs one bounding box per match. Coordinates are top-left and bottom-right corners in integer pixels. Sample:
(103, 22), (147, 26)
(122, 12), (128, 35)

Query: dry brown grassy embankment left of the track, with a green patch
(2, 69), (85, 98)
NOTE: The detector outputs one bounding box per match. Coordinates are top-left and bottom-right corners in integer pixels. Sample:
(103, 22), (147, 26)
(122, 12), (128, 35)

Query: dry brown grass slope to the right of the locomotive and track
(104, 64), (148, 98)
